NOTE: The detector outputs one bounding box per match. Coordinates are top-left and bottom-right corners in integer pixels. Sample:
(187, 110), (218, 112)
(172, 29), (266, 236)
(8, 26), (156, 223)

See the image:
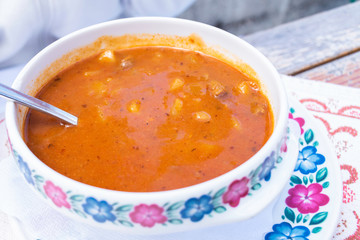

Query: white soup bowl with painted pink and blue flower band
(6, 18), (298, 234)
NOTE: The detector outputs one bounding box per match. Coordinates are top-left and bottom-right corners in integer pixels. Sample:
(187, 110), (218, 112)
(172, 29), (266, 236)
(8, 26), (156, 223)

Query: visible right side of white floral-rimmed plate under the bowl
(264, 99), (342, 240)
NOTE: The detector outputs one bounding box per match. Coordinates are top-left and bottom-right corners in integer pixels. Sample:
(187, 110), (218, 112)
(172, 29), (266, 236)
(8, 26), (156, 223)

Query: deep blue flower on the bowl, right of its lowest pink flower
(180, 195), (213, 222)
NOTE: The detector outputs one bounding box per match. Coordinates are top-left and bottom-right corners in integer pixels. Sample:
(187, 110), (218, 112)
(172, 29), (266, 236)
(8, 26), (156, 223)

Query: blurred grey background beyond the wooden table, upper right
(179, 0), (355, 36)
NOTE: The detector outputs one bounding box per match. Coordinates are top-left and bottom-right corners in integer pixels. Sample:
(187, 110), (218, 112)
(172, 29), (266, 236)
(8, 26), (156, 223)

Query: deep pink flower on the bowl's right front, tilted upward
(223, 177), (249, 207)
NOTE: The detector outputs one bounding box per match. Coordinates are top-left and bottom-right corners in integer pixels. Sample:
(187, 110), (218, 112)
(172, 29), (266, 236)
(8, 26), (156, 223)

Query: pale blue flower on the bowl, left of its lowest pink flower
(82, 197), (116, 222)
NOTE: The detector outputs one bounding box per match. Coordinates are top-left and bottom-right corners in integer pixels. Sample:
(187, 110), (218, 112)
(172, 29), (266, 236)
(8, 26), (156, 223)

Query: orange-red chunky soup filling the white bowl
(25, 46), (274, 192)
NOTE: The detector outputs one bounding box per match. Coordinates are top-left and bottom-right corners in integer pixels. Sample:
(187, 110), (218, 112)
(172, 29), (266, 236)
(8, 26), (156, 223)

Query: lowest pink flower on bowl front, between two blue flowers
(130, 204), (167, 227)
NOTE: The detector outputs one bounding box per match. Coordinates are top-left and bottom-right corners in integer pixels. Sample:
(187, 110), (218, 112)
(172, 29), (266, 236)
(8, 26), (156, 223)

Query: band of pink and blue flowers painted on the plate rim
(265, 108), (330, 240)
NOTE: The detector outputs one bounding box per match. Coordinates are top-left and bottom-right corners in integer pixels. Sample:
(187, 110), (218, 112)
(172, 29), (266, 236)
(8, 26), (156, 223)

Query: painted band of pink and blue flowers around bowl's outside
(13, 124), (290, 228)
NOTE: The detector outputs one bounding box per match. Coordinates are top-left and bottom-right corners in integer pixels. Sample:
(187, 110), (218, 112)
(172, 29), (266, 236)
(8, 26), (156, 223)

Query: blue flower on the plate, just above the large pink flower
(294, 146), (325, 174)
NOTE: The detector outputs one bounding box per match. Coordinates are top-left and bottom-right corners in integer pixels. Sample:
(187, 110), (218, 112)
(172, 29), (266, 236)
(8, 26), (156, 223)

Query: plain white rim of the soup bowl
(5, 17), (288, 202)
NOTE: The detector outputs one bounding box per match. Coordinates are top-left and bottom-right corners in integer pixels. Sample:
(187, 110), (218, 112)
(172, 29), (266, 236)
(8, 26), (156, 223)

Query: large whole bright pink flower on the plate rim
(285, 183), (329, 214)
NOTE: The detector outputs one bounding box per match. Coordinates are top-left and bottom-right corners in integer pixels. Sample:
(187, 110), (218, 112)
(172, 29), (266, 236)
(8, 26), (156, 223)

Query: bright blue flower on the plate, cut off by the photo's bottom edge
(265, 222), (310, 240)
